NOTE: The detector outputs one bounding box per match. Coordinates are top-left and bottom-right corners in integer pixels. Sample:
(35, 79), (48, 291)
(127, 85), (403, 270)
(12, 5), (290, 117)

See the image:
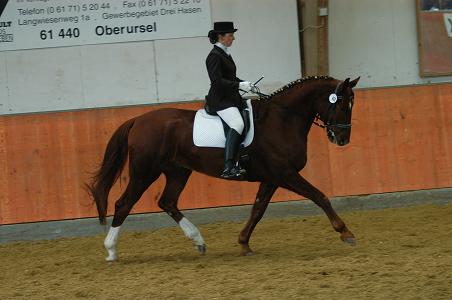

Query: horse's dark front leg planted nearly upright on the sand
(239, 183), (278, 255)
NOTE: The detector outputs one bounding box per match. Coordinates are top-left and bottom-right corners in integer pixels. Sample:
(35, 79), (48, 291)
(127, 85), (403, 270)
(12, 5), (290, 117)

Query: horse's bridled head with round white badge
(317, 77), (359, 146)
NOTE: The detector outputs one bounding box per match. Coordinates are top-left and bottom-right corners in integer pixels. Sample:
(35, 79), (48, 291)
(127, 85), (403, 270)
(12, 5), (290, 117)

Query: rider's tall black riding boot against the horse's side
(221, 128), (245, 178)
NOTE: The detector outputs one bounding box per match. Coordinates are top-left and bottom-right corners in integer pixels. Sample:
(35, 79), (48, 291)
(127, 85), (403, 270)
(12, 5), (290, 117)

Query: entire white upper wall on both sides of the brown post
(0, 0), (452, 114)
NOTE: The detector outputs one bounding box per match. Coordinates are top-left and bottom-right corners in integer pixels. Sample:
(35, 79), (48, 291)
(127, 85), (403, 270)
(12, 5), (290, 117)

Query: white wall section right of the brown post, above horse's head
(328, 0), (452, 87)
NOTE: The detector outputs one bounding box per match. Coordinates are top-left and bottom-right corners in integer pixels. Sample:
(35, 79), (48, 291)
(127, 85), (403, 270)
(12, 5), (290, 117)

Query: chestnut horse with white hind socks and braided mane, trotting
(88, 76), (359, 261)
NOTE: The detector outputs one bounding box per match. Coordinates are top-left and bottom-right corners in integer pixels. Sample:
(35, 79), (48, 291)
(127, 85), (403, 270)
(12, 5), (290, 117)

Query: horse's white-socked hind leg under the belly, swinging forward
(158, 166), (206, 254)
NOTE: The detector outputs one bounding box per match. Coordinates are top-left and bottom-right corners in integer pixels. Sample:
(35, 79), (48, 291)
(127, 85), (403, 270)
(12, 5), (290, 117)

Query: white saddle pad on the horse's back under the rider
(193, 100), (254, 148)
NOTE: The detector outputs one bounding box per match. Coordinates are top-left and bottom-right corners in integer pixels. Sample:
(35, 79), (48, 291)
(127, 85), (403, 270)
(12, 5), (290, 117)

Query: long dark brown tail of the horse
(86, 118), (135, 225)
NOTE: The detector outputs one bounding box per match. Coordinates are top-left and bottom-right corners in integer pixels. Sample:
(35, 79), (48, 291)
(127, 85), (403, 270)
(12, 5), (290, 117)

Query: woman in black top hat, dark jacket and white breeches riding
(206, 22), (254, 178)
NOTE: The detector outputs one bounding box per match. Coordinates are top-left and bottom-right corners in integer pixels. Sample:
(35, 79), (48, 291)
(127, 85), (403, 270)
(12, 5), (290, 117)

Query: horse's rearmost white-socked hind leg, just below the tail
(104, 170), (161, 261)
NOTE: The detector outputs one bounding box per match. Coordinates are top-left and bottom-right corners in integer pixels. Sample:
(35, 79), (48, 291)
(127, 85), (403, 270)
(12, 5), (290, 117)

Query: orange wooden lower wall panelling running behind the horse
(0, 84), (452, 224)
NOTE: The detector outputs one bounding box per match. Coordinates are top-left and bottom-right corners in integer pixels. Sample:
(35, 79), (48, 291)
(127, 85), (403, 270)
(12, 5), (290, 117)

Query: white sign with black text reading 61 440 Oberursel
(0, 0), (211, 51)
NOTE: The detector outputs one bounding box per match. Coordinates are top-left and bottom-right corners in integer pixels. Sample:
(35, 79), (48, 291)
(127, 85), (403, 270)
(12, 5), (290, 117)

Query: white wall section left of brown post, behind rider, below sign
(0, 0), (301, 114)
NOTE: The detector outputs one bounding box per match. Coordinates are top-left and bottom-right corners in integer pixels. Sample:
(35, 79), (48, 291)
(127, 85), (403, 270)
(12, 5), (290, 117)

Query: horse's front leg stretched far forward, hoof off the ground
(281, 172), (356, 245)
